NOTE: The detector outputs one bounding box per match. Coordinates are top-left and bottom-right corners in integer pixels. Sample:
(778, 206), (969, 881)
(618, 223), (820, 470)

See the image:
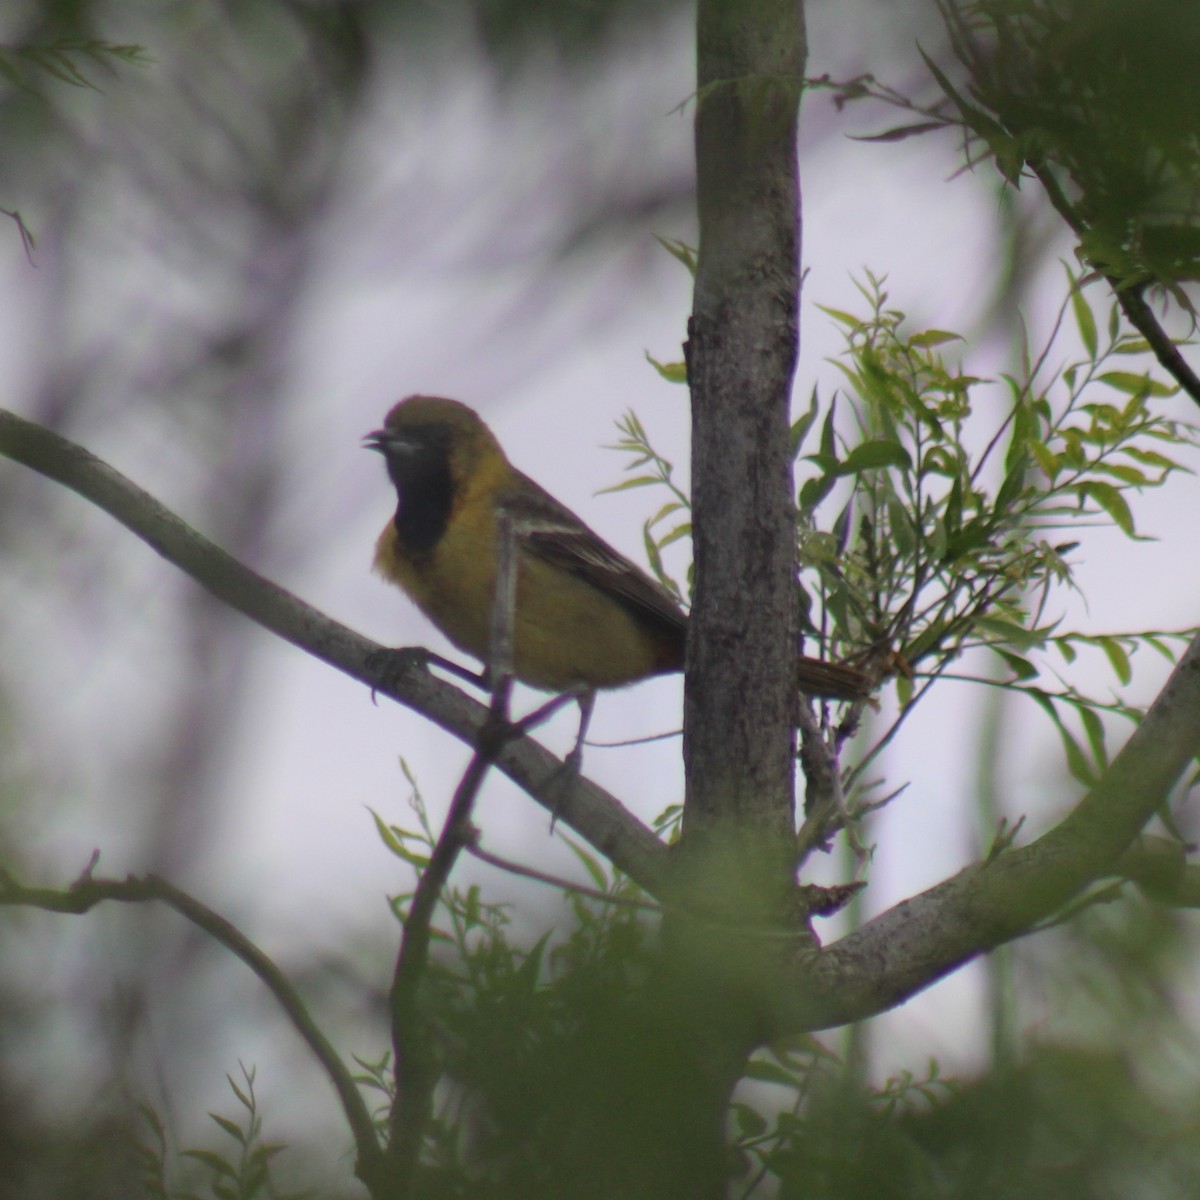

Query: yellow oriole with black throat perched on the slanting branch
(366, 396), (871, 700)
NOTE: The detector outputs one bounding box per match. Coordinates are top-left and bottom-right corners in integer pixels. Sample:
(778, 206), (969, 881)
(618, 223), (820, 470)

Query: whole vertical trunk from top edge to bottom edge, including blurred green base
(643, 0), (805, 1198)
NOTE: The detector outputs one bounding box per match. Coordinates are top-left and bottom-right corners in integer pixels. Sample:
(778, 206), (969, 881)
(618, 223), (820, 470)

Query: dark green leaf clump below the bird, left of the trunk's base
(374, 776), (650, 1196)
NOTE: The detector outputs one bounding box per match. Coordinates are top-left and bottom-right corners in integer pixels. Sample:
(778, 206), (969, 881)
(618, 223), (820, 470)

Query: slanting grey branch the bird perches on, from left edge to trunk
(0, 409), (668, 895)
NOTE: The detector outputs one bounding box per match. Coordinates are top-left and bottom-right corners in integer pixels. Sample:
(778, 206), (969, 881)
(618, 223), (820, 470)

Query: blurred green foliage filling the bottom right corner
(733, 899), (1200, 1200)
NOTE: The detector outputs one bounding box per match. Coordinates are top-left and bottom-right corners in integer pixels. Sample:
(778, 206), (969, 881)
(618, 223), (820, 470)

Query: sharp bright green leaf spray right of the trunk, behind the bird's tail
(793, 276), (1198, 720)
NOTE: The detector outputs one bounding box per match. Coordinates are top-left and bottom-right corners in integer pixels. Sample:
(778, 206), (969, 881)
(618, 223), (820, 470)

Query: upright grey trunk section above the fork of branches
(684, 0), (806, 889)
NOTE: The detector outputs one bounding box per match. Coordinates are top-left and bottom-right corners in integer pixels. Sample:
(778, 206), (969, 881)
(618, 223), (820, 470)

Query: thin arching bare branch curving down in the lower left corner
(0, 854), (384, 1195)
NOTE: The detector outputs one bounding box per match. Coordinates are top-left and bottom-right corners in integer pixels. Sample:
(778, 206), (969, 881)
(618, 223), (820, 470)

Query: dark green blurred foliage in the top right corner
(931, 0), (1200, 305)
